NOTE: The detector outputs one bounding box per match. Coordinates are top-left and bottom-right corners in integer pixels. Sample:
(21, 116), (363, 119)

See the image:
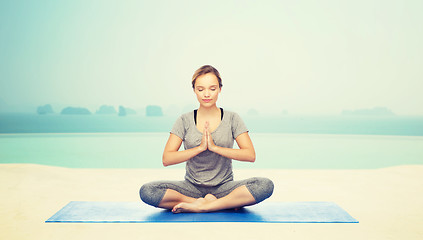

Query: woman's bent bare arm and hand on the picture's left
(162, 132), (207, 167)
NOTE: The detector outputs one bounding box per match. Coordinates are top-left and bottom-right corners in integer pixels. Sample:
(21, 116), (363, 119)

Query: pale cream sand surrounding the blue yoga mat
(0, 164), (423, 240)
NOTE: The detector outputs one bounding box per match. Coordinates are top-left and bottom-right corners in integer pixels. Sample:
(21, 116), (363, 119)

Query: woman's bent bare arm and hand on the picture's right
(207, 132), (256, 162)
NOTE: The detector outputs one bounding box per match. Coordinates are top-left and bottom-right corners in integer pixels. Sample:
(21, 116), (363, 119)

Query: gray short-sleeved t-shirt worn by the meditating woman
(170, 110), (248, 186)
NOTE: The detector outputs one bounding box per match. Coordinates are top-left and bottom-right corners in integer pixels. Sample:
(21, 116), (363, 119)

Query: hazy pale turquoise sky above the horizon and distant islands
(0, 0), (423, 115)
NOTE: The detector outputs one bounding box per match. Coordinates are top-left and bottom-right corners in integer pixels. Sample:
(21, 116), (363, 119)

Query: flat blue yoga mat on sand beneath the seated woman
(46, 201), (358, 223)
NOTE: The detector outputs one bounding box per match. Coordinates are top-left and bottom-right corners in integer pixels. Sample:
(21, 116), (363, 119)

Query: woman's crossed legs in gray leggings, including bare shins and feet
(140, 177), (274, 213)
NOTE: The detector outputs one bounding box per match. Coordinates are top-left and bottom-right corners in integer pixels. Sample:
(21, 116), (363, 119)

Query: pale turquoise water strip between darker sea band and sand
(0, 133), (423, 169)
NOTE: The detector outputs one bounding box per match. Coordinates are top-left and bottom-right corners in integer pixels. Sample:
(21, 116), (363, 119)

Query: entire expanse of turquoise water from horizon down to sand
(0, 113), (423, 169)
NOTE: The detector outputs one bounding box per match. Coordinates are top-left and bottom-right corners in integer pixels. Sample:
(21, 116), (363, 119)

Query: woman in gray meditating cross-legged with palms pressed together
(140, 65), (273, 213)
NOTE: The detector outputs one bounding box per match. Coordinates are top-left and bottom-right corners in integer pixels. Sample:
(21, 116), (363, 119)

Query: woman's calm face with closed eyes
(194, 73), (221, 107)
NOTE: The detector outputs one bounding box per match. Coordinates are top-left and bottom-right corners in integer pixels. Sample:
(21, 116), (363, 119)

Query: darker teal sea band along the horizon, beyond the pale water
(0, 113), (423, 136)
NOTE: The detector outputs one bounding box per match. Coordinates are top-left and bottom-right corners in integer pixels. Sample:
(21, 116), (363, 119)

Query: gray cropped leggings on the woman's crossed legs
(140, 177), (274, 207)
